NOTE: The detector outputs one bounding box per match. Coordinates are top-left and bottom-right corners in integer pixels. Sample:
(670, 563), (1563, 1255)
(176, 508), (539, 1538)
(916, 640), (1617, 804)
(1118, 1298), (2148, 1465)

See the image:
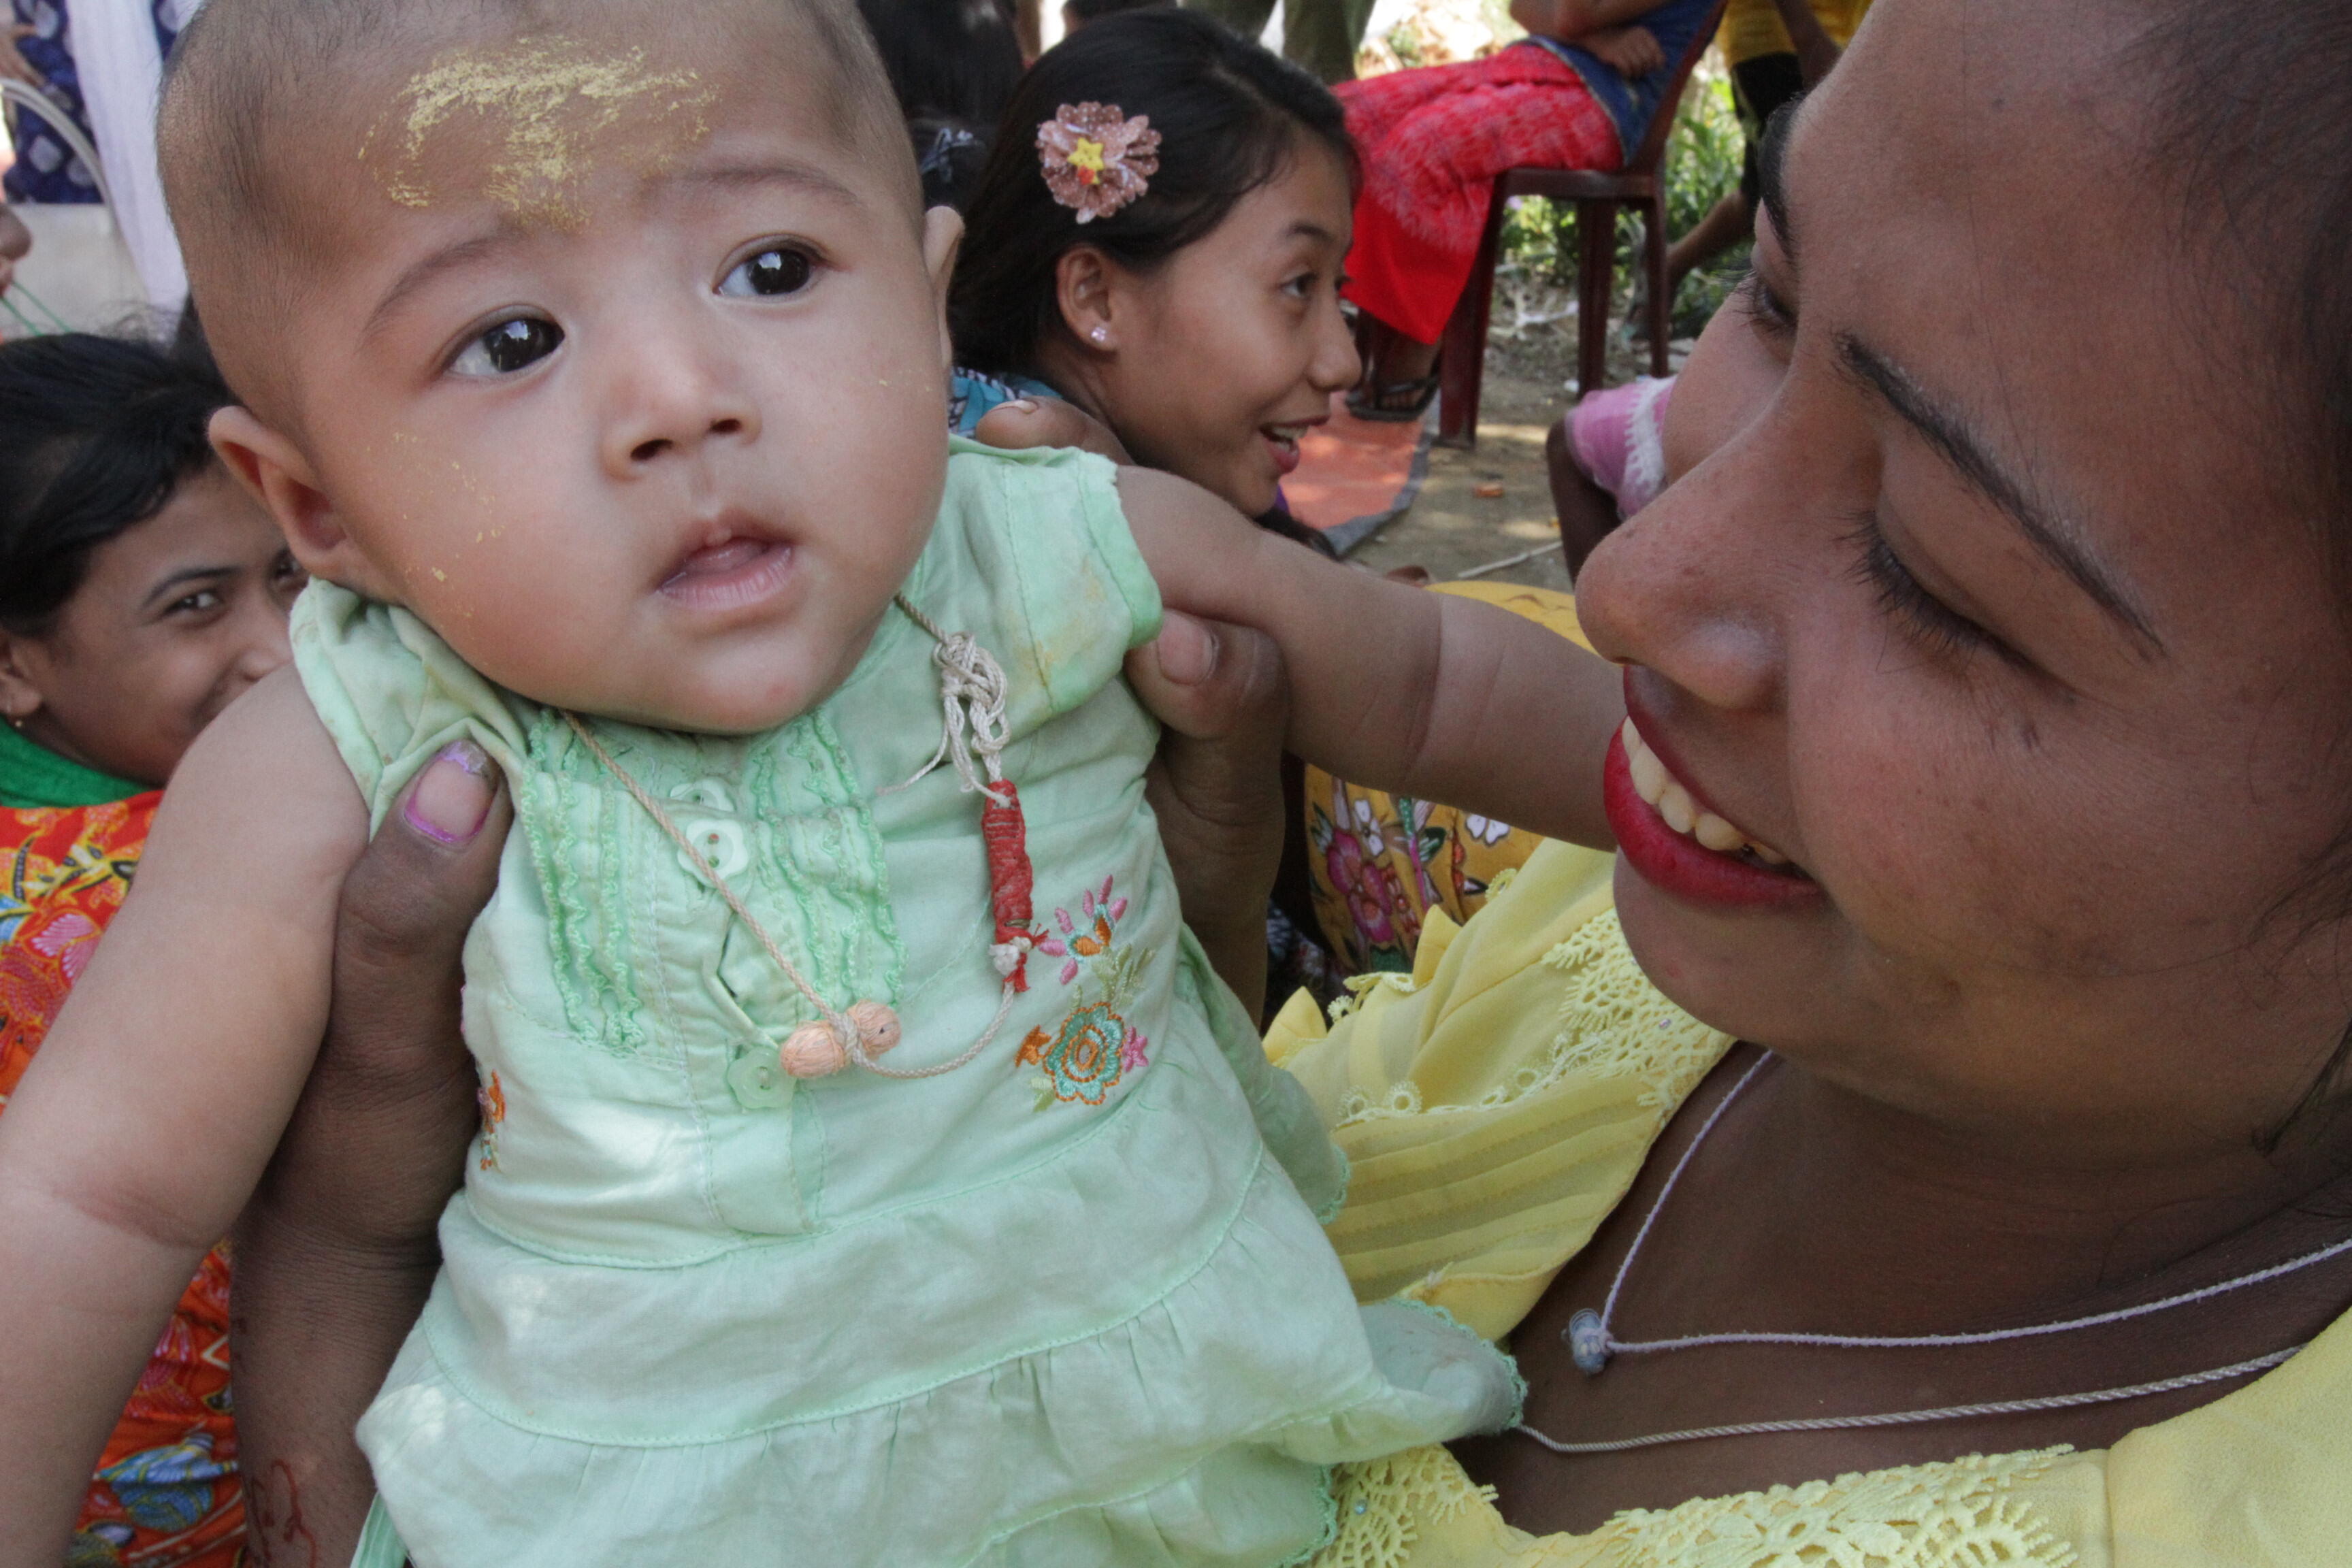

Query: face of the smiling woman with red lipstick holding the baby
(1578, 0), (2352, 1164)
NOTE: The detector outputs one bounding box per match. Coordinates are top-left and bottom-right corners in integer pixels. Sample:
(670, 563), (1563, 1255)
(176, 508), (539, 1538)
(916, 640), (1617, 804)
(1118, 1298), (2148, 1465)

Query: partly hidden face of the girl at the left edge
(0, 466), (304, 785)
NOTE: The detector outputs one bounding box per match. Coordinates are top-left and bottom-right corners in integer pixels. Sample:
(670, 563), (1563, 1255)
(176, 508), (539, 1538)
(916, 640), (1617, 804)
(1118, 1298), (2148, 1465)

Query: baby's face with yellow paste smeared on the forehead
(218, 42), (958, 731)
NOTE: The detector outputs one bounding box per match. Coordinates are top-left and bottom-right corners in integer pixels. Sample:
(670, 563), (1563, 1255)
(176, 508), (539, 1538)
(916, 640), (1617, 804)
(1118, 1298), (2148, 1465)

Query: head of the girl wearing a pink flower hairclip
(948, 10), (1357, 557)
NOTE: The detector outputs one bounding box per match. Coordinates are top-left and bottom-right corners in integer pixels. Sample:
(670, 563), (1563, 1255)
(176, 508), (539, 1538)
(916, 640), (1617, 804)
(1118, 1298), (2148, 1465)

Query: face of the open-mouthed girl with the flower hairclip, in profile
(1082, 144), (1357, 517)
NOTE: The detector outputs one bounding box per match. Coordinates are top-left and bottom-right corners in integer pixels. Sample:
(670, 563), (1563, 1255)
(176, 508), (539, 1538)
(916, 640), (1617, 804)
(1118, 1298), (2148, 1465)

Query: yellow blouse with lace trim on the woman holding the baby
(1265, 844), (2352, 1568)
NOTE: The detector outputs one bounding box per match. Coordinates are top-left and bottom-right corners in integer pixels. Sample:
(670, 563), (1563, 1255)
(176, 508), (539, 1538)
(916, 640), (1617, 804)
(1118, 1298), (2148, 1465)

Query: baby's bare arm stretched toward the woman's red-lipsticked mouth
(1120, 468), (1625, 847)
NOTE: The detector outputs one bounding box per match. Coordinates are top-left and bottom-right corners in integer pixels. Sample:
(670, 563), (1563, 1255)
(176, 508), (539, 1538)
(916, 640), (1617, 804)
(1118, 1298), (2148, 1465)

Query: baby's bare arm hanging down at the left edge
(0, 670), (367, 1568)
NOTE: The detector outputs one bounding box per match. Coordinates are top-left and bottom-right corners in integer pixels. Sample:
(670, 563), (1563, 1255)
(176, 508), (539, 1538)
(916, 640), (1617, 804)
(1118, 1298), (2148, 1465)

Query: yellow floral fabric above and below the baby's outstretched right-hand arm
(1305, 583), (1583, 973)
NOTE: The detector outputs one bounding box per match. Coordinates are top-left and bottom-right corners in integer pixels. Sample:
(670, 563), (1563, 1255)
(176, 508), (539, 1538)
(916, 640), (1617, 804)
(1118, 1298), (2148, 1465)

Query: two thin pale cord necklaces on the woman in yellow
(1512, 1051), (2352, 1455)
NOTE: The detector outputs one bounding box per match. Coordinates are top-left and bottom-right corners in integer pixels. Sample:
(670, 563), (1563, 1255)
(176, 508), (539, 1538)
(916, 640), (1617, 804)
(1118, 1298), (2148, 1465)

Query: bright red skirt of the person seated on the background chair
(1331, 45), (1623, 343)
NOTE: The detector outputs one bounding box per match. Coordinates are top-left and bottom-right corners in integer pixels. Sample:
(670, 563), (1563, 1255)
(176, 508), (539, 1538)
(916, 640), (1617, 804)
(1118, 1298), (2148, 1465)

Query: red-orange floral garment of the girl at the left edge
(0, 792), (244, 1568)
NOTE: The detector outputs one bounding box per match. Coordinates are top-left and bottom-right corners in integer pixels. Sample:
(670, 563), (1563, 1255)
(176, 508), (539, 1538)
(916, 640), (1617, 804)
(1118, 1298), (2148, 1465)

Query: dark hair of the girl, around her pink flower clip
(948, 10), (1355, 374)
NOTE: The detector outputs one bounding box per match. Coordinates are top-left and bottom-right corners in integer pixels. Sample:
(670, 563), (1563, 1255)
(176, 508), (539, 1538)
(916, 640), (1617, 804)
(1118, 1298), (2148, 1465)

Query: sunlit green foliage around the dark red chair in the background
(1498, 59), (1748, 336)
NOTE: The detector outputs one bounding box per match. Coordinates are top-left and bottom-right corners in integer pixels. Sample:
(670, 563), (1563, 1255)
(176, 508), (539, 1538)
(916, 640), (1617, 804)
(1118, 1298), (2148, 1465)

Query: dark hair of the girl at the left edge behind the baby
(0, 331), (235, 637)
